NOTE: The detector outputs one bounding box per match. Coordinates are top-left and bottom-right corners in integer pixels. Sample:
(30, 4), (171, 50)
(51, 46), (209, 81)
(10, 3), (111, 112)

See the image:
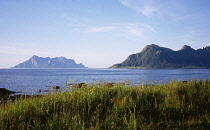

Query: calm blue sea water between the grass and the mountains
(0, 69), (210, 94)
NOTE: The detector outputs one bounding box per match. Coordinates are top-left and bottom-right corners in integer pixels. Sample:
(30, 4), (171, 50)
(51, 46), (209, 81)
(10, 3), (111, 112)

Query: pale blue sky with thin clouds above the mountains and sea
(0, 0), (210, 68)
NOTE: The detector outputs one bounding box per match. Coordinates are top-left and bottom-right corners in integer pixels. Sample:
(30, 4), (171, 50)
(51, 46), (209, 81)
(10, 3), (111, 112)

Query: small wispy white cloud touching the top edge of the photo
(119, 0), (156, 17)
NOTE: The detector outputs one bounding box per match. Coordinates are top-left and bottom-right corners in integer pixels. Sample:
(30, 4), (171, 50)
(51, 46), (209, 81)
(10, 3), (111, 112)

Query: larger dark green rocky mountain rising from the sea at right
(110, 44), (210, 68)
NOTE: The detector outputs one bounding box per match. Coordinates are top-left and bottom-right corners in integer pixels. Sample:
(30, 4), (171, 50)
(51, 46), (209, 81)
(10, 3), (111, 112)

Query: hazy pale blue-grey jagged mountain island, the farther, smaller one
(12, 55), (86, 68)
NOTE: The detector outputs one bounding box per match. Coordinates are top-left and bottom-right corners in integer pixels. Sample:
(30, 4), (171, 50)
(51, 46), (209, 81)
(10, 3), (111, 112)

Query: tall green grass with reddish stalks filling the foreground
(0, 80), (210, 130)
